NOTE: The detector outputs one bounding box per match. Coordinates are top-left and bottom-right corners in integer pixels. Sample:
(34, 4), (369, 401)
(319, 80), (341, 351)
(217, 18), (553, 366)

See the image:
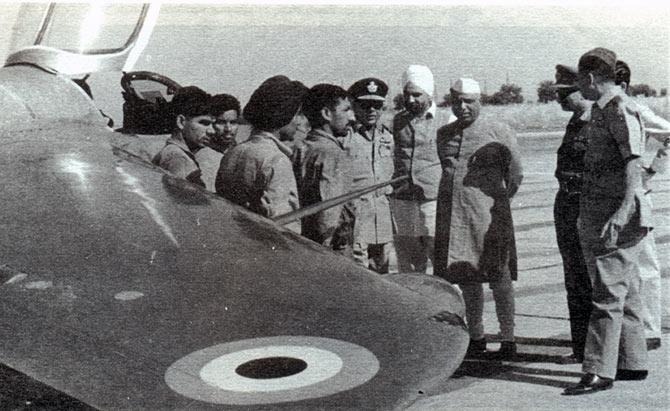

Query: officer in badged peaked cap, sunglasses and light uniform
(347, 77), (393, 274)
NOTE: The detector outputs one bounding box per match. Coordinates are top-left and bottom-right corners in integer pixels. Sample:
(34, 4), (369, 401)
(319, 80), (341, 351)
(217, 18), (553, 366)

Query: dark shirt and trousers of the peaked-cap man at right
(554, 113), (591, 362)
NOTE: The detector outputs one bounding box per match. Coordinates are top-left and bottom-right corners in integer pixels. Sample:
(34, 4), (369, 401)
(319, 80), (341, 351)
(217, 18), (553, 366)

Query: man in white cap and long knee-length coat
(434, 78), (522, 359)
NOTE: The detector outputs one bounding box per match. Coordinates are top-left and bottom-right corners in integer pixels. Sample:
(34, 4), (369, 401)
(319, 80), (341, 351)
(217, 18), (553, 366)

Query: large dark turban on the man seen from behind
(243, 76), (308, 131)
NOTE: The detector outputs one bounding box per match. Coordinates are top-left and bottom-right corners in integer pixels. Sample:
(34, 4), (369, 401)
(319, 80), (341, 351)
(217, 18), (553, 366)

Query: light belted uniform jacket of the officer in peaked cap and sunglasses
(346, 125), (393, 244)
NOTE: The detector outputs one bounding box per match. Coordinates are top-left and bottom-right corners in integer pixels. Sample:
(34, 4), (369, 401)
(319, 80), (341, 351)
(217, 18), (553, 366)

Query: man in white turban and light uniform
(391, 65), (456, 273)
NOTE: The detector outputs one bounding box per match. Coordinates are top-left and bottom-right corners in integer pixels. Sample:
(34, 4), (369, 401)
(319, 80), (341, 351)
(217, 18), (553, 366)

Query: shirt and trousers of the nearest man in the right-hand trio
(578, 88), (651, 378)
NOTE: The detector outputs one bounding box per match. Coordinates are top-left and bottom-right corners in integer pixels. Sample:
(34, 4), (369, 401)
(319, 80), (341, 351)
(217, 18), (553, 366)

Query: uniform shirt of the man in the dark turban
(216, 131), (300, 232)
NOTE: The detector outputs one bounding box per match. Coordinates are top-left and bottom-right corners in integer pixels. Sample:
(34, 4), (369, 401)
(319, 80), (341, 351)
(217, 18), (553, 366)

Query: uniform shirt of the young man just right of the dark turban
(293, 130), (354, 249)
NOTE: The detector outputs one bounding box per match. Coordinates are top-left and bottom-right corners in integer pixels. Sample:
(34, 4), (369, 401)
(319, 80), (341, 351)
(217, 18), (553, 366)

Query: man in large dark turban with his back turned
(216, 76), (307, 232)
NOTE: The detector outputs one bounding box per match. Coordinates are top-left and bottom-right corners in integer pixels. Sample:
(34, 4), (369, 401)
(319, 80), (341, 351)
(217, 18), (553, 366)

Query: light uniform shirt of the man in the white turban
(393, 102), (455, 201)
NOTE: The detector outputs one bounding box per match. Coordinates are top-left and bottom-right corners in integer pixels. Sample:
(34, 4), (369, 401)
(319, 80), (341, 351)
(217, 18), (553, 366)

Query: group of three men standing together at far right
(554, 48), (670, 395)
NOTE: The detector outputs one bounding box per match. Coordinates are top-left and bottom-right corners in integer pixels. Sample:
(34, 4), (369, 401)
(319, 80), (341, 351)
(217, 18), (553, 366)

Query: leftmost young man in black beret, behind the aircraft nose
(152, 86), (214, 187)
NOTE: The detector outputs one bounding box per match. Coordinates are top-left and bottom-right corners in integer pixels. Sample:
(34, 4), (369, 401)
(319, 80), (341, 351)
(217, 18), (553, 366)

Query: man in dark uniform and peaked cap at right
(553, 64), (592, 364)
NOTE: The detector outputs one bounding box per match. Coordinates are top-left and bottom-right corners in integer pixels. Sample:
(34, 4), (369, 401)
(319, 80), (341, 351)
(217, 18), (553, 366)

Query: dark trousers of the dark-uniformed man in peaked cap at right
(554, 191), (592, 360)
